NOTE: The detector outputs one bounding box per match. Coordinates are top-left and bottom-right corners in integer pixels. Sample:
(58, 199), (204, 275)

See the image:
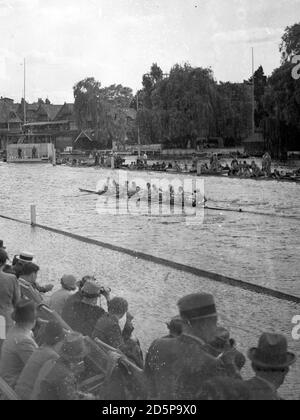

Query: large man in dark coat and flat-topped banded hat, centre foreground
(145, 293), (240, 400)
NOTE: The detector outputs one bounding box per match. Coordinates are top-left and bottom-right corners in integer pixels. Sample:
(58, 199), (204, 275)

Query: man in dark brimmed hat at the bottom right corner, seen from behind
(246, 333), (296, 401)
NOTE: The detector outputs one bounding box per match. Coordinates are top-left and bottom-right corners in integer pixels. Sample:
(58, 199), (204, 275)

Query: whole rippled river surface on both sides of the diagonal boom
(0, 164), (300, 398)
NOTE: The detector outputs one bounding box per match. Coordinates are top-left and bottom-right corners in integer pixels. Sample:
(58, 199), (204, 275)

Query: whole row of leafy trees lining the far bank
(74, 24), (300, 158)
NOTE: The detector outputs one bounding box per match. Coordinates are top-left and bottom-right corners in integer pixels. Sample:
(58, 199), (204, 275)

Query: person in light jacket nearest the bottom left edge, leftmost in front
(0, 300), (38, 388)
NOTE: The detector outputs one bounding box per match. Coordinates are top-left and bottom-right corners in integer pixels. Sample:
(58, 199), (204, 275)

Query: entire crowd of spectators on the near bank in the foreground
(0, 241), (296, 401)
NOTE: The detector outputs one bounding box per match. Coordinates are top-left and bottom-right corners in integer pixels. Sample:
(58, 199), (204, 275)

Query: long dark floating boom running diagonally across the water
(0, 215), (300, 305)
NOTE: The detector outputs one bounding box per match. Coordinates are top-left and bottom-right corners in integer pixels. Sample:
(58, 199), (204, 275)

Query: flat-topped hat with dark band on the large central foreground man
(177, 293), (217, 320)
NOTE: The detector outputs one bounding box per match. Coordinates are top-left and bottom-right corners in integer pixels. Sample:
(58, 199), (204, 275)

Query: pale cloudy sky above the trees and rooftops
(0, 0), (300, 103)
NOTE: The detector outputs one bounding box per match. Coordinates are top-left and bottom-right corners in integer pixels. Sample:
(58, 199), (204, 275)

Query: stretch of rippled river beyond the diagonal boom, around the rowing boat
(0, 165), (300, 295)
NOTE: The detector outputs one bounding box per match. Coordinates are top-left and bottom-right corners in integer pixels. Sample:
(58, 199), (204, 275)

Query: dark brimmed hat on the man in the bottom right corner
(248, 333), (296, 369)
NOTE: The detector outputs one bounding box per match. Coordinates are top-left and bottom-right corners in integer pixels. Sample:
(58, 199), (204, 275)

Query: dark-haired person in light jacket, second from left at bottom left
(15, 321), (65, 400)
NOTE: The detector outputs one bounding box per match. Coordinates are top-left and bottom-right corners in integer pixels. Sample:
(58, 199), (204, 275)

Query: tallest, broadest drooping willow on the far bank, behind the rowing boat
(138, 64), (216, 147)
